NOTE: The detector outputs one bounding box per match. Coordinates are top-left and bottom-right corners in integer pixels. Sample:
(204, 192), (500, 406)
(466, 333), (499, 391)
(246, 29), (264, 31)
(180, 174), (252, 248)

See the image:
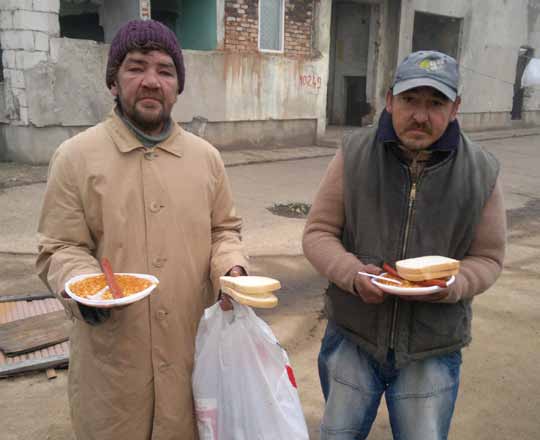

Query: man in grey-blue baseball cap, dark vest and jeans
(303, 51), (506, 440)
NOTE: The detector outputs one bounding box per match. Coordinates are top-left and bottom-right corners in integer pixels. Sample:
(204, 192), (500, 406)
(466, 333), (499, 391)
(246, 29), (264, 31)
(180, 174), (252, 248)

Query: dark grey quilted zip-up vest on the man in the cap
(326, 130), (499, 367)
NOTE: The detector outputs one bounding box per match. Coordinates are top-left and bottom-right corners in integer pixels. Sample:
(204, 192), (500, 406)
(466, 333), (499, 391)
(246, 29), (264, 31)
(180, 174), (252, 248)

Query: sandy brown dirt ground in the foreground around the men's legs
(0, 248), (540, 440)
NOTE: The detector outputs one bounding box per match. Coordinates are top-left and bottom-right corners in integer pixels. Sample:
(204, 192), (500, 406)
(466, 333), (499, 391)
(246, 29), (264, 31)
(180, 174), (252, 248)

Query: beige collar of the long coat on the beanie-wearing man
(105, 109), (184, 157)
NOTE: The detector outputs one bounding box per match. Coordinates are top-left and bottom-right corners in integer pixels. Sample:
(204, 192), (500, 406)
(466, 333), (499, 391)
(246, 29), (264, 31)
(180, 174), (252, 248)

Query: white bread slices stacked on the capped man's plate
(396, 255), (459, 281)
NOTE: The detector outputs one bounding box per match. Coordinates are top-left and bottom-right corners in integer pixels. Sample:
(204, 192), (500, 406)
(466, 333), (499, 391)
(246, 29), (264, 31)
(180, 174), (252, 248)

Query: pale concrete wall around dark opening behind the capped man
(399, 0), (540, 129)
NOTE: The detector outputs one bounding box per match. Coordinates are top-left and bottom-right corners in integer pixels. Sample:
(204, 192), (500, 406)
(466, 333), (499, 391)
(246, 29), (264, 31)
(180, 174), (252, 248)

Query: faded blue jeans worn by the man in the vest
(319, 322), (461, 440)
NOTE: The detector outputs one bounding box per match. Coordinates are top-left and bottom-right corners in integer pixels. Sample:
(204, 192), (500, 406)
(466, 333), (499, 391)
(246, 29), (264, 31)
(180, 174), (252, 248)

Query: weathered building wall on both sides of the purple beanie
(0, 0), (331, 163)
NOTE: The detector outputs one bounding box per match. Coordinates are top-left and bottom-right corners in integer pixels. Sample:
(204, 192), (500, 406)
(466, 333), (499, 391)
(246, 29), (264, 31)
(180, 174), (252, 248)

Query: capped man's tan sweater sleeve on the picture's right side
(442, 175), (506, 302)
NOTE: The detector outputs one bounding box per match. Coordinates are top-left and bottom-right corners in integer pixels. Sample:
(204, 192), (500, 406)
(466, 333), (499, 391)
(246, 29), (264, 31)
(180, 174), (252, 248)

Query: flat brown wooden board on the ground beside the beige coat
(0, 310), (72, 356)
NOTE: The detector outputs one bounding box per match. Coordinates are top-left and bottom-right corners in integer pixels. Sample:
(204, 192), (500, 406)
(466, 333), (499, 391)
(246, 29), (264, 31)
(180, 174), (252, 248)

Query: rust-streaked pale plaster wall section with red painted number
(173, 50), (326, 121)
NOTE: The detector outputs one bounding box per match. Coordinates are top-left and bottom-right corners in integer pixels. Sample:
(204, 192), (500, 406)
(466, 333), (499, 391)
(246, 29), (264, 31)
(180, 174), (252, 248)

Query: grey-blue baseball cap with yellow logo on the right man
(392, 50), (459, 101)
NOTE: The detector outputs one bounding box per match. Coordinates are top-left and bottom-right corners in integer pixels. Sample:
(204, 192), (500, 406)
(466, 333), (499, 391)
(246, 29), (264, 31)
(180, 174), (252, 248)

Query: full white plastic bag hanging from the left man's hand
(192, 303), (309, 440)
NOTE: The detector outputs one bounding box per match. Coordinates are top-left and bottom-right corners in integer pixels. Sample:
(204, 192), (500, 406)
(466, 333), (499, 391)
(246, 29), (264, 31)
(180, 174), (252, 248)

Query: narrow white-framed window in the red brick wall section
(259, 0), (285, 52)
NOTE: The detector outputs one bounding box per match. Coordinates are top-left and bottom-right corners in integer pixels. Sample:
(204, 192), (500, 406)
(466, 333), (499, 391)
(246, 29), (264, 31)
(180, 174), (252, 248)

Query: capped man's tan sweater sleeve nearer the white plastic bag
(302, 150), (364, 292)
